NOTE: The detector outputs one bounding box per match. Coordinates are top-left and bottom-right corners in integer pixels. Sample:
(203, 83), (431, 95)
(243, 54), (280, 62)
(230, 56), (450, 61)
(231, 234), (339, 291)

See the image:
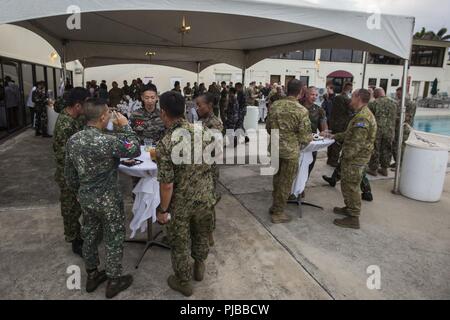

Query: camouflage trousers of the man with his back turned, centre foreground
(167, 204), (213, 282)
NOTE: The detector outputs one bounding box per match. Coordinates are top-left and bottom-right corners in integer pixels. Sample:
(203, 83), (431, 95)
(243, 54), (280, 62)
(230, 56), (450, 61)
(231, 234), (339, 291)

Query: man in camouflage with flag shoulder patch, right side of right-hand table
(332, 89), (377, 229)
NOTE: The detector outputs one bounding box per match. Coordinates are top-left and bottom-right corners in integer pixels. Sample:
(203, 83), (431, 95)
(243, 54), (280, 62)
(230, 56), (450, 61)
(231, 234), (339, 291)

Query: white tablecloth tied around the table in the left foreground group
(119, 147), (160, 238)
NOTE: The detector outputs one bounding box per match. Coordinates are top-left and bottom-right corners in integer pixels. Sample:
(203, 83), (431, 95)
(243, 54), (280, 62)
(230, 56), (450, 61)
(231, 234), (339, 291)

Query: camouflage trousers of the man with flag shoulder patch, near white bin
(341, 162), (365, 217)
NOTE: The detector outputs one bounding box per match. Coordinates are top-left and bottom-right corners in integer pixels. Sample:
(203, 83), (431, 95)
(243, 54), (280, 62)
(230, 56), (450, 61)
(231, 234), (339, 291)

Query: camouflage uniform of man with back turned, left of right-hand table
(266, 97), (312, 215)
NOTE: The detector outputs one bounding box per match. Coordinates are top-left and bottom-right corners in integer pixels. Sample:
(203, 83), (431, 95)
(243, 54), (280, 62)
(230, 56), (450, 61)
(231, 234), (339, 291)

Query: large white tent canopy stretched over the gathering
(0, 0), (414, 72)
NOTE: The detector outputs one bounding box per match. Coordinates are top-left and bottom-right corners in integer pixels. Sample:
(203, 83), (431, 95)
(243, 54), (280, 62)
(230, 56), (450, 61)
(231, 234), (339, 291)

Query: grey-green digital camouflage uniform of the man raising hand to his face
(65, 125), (140, 278)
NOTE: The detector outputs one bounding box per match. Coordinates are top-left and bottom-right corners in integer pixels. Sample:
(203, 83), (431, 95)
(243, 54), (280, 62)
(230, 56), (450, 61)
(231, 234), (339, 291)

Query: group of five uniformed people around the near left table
(53, 84), (223, 298)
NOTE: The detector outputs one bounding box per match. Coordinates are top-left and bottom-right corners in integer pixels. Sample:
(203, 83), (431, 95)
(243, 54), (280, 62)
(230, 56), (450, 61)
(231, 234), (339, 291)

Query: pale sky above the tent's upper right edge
(255, 0), (450, 33)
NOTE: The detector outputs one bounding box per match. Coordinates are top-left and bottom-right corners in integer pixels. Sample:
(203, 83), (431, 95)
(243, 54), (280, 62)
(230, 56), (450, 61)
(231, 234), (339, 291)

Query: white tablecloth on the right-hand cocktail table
(291, 139), (334, 197)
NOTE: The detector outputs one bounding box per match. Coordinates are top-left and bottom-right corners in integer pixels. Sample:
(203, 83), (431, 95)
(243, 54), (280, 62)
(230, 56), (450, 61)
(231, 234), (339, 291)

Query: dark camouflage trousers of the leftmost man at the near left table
(58, 181), (81, 242)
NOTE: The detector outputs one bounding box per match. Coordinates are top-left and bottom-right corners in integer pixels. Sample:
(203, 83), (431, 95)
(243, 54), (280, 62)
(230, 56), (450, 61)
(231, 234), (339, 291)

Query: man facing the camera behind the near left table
(130, 85), (165, 145)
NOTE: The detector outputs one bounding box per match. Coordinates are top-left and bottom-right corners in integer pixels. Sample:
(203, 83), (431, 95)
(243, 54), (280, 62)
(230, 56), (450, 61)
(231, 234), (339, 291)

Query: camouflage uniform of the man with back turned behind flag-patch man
(369, 97), (397, 171)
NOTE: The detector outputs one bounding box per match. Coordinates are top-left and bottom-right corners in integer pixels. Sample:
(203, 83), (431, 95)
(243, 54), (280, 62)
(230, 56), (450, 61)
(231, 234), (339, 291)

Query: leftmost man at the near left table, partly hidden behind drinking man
(53, 87), (89, 256)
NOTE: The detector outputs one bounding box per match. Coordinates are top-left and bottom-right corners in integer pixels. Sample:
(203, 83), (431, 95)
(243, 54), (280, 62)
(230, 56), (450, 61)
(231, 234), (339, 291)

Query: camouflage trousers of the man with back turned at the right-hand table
(270, 158), (298, 214)
